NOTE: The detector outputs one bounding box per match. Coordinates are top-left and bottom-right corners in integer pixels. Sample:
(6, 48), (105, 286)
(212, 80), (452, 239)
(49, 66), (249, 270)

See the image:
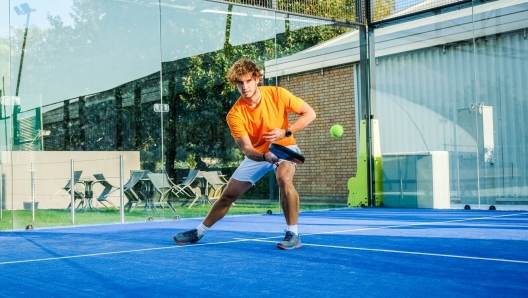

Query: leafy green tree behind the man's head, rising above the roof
(173, 1), (350, 170)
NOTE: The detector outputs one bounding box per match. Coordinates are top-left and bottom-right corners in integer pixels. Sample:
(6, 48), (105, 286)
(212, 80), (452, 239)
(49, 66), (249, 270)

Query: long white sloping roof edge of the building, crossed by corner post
(265, 0), (528, 78)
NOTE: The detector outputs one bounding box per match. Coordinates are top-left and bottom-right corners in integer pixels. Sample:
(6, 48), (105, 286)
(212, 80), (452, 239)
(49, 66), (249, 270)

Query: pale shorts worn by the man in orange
(231, 145), (301, 185)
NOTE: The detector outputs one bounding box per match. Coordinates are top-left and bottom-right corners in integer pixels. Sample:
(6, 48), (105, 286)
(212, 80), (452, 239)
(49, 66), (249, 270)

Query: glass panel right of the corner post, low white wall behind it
(374, 1), (482, 208)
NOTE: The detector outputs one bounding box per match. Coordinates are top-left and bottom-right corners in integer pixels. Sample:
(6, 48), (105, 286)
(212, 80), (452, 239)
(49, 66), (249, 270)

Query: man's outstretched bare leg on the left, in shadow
(202, 179), (251, 228)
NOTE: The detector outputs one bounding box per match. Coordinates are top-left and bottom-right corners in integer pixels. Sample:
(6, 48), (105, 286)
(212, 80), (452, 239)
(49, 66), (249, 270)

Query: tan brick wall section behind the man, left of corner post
(279, 66), (357, 203)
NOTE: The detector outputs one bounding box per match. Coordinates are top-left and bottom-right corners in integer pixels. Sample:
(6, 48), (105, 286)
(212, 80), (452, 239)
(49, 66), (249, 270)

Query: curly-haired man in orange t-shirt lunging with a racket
(174, 59), (316, 249)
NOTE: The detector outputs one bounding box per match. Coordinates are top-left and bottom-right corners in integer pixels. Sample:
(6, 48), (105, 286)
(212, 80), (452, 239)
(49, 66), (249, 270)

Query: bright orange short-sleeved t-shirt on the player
(226, 86), (304, 153)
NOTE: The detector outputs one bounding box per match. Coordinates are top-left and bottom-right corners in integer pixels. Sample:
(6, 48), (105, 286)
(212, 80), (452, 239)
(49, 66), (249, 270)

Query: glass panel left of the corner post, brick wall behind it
(272, 14), (359, 209)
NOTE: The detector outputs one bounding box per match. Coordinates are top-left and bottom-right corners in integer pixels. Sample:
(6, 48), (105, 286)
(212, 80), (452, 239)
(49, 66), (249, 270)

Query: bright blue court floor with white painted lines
(0, 208), (528, 298)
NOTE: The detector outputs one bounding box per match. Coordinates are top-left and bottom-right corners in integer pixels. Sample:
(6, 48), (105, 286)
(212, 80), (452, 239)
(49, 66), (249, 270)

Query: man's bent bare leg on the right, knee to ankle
(276, 162), (300, 225)
